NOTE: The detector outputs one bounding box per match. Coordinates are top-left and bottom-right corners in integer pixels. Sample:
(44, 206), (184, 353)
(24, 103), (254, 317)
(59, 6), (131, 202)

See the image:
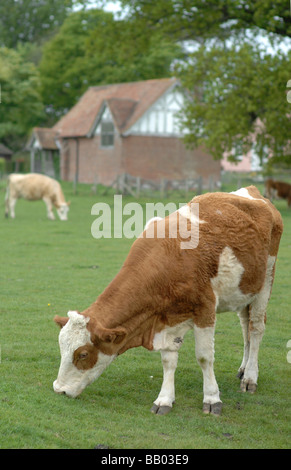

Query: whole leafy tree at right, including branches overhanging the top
(105, 0), (291, 162)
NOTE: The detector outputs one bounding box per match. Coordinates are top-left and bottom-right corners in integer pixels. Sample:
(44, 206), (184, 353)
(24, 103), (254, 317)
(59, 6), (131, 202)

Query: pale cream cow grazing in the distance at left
(5, 173), (70, 220)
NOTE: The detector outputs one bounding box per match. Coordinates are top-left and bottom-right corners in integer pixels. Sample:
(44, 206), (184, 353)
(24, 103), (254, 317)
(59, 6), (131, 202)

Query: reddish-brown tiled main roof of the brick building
(53, 78), (178, 137)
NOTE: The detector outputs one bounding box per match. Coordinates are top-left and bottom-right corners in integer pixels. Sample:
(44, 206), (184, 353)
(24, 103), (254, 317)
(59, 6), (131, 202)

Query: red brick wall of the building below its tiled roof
(61, 135), (220, 185)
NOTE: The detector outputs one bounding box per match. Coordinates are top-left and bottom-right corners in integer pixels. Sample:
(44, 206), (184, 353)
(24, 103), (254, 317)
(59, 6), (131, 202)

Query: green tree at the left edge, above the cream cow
(0, 47), (44, 150)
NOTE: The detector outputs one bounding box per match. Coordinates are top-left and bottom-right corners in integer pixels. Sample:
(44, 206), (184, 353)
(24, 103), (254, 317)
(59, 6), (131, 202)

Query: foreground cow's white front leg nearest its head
(151, 350), (178, 415)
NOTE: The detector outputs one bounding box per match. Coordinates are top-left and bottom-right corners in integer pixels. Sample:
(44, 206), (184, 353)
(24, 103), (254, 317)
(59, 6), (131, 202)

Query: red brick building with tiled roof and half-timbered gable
(30, 78), (220, 187)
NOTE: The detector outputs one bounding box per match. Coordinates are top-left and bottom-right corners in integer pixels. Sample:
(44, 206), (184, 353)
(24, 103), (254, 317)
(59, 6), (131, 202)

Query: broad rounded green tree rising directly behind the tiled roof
(39, 10), (180, 116)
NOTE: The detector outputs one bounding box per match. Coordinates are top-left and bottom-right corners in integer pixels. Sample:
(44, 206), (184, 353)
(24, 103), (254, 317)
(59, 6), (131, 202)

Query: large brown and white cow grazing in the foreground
(53, 186), (283, 414)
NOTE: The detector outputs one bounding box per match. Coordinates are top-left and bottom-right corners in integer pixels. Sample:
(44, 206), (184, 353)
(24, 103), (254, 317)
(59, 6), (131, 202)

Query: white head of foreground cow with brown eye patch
(53, 312), (116, 398)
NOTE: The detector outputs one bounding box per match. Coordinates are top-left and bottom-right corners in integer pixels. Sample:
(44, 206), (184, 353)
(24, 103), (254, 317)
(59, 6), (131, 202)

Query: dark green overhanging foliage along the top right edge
(114, 0), (291, 40)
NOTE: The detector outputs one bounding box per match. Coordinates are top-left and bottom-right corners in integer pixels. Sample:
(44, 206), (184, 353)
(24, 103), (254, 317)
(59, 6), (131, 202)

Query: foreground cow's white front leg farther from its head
(194, 325), (222, 415)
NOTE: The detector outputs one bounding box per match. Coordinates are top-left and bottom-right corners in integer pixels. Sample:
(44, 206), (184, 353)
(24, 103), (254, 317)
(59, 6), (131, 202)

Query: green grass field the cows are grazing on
(0, 180), (291, 449)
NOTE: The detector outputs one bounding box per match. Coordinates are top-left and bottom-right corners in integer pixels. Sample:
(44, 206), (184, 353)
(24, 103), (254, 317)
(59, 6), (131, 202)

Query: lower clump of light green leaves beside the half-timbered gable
(177, 44), (291, 160)
